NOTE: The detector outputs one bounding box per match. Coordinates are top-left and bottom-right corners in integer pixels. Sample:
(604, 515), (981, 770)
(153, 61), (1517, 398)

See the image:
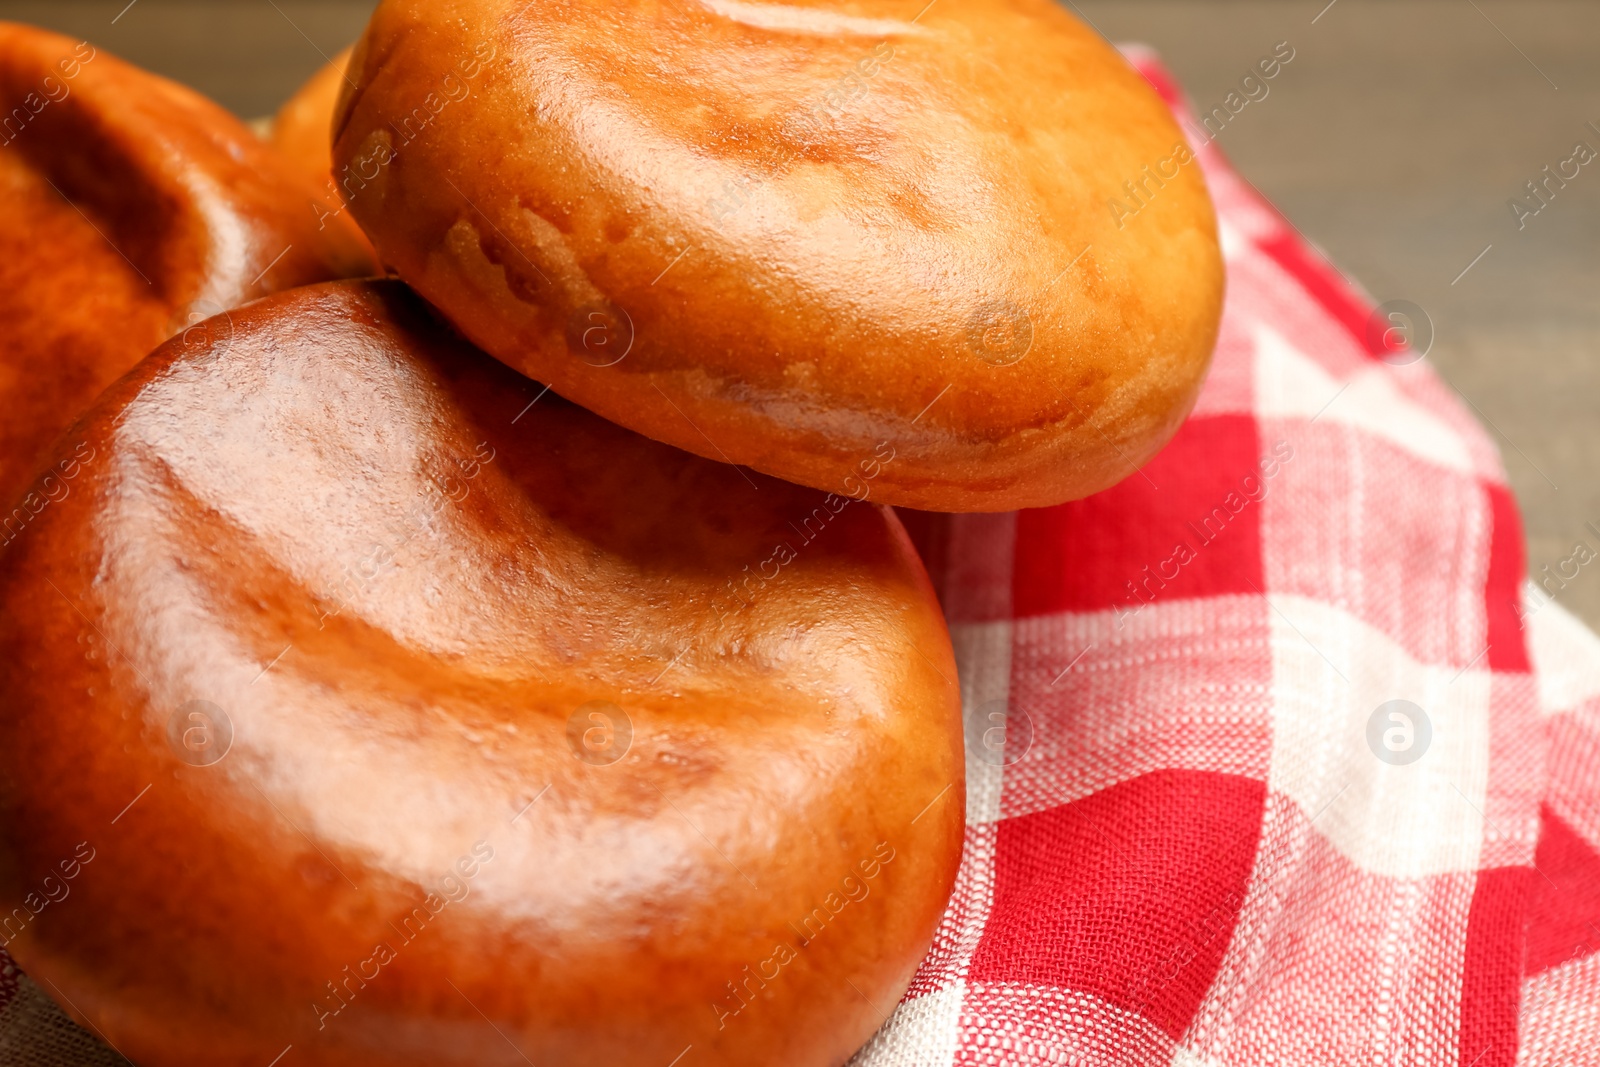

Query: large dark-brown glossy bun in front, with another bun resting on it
(0, 282), (965, 1067)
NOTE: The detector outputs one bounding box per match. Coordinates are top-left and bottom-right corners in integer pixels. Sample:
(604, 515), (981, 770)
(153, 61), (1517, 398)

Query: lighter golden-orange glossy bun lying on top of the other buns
(334, 0), (1222, 510)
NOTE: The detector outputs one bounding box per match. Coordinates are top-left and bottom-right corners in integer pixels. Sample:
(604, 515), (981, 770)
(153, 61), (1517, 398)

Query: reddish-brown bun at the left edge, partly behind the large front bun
(0, 22), (373, 511)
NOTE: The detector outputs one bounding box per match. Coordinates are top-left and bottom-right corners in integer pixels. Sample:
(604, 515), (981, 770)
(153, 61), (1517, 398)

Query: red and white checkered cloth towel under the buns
(0, 50), (1600, 1067)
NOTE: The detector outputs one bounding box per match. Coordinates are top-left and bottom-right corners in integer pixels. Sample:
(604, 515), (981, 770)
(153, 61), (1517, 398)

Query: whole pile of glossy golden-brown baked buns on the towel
(0, 0), (1222, 1067)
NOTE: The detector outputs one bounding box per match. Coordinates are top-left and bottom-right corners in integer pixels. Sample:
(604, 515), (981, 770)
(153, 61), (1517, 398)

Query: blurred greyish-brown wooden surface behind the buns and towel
(0, 0), (1600, 627)
